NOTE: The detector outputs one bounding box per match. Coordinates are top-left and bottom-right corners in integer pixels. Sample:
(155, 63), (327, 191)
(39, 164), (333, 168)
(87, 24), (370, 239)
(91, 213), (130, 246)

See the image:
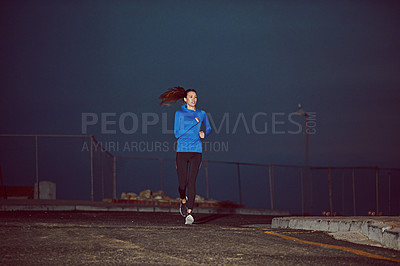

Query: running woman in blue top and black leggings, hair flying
(160, 87), (211, 224)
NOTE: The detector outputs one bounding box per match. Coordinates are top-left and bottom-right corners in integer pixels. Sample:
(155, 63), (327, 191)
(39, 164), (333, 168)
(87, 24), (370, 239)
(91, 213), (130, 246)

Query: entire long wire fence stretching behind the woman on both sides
(0, 135), (400, 215)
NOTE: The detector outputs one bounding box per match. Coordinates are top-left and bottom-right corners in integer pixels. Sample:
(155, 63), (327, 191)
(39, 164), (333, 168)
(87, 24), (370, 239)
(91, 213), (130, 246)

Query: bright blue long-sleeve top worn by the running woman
(174, 104), (211, 153)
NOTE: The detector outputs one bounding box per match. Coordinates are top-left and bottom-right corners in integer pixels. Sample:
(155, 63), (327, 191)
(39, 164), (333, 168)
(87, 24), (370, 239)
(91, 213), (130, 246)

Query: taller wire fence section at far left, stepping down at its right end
(0, 134), (116, 200)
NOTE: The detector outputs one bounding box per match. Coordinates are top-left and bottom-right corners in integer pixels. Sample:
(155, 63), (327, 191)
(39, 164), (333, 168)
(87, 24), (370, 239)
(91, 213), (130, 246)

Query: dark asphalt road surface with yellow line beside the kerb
(0, 211), (400, 265)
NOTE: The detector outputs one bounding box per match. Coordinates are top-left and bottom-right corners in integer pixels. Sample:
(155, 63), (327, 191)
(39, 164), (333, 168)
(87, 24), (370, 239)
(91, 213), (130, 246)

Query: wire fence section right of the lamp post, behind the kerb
(310, 167), (400, 215)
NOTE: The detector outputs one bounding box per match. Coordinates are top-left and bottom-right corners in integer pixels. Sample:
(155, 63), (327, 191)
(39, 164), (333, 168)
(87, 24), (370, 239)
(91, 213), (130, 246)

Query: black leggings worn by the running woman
(176, 152), (202, 210)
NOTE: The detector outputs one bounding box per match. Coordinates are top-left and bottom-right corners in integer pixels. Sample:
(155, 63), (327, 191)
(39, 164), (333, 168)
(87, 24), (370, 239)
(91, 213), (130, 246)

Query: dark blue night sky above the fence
(0, 1), (400, 210)
